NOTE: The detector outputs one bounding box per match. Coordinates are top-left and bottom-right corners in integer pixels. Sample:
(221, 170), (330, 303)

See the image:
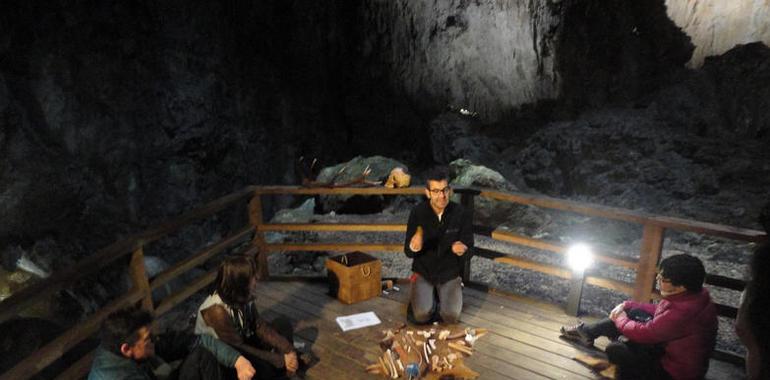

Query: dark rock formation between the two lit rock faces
(555, 0), (693, 110)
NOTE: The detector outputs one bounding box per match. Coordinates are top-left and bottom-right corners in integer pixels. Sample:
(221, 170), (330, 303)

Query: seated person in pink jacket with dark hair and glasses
(561, 255), (718, 380)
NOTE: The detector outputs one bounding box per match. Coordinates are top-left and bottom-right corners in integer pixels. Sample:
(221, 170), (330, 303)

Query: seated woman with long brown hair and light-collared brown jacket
(195, 256), (298, 379)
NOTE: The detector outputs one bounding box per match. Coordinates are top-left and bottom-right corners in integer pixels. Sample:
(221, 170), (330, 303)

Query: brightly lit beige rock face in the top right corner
(666, 0), (770, 67)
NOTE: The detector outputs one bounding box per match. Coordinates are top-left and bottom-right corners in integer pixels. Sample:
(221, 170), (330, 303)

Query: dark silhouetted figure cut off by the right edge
(735, 243), (770, 380)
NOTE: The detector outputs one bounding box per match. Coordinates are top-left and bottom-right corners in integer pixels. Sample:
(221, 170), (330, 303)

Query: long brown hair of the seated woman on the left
(214, 255), (258, 305)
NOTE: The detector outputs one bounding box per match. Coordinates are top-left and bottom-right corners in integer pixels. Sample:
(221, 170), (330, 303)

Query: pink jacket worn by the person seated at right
(615, 288), (718, 380)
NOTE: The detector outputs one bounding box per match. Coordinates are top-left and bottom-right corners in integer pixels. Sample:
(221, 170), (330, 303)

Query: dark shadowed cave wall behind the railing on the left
(0, 0), (427, 262)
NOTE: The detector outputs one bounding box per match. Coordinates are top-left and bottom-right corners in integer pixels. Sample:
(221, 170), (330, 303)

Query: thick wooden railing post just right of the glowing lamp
(634, 224), (665, 302)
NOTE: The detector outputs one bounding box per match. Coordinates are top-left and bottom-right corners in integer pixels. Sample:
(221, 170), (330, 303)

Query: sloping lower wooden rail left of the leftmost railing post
(0, 288), (144, 380)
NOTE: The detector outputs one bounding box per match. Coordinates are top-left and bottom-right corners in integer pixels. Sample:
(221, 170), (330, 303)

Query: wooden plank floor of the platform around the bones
(249, 281), (741, 380)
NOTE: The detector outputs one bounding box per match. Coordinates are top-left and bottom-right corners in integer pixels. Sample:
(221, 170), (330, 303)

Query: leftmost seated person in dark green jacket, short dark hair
(88, 308), (255, 380)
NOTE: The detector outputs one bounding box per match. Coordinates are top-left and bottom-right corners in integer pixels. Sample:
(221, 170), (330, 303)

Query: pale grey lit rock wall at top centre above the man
(361, 0), (559, 120)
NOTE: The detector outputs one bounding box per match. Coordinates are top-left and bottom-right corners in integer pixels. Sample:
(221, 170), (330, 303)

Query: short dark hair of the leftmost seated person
(101, 307), (153, 355)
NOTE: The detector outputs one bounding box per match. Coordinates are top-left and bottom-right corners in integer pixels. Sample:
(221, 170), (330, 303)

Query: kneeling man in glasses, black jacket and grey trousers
(404, 170), (473, 323)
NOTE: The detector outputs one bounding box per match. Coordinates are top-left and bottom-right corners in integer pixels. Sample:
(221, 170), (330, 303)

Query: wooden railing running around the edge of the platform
(0, 186), (766, 380)
